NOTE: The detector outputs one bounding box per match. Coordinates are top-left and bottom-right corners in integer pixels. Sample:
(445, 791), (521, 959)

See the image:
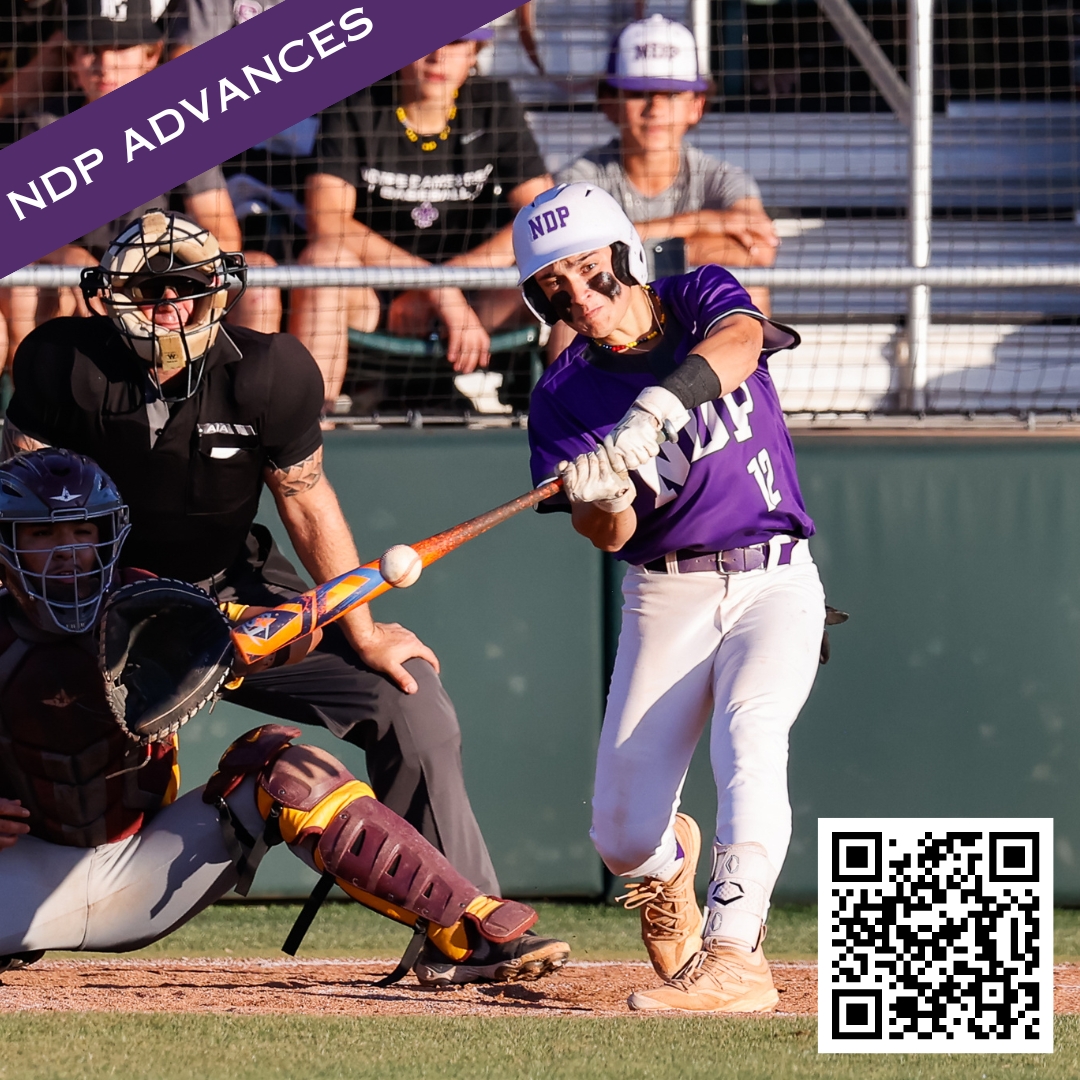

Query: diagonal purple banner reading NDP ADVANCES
(0, 0), (513, 276)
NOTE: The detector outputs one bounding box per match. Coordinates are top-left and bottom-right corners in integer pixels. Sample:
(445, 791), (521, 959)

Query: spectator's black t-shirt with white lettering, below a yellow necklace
(315, 79), (548, 262)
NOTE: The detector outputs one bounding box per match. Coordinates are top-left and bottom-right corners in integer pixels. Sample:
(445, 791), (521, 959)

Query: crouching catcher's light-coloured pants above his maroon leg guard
(0, 779), (262, 957)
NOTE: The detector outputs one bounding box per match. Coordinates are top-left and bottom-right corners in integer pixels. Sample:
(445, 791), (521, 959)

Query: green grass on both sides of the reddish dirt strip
(8, 903), (1080, 1080)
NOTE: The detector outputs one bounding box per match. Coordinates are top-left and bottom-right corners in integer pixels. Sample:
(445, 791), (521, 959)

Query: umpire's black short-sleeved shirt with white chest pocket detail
(8, 315), (323, 581)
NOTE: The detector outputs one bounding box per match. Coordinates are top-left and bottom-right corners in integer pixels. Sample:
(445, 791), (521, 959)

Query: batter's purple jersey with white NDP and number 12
(529, 266), (813, 565)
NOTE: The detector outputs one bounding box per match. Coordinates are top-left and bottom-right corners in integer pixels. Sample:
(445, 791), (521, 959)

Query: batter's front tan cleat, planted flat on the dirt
(626, 942), (780, 1012)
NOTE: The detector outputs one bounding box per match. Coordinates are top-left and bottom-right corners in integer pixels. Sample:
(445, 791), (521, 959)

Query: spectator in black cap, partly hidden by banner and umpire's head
(8, 0), (281, 367)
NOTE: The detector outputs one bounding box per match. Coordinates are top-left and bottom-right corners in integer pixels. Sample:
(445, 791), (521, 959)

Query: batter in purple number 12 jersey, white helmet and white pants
(514, 184), (825, 1012)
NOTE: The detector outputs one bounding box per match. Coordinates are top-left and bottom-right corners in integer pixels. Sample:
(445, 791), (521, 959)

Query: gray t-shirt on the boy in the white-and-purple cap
(555, 138), (761, 221)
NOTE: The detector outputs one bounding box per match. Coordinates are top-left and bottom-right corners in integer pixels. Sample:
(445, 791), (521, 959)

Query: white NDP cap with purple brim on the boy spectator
(604, 14), (708, 91)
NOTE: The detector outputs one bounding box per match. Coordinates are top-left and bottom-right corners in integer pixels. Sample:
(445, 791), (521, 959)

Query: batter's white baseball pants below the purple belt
(591, 542), (825, 877)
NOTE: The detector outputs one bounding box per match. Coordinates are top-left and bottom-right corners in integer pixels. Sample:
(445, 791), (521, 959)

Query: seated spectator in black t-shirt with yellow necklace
(289, 29), (552, 408)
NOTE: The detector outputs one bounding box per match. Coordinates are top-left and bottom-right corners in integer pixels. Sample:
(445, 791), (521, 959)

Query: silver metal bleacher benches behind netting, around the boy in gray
(520, 104), (1080, 413)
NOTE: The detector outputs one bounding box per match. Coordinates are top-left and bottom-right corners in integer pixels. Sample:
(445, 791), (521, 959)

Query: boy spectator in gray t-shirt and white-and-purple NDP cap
(550, 14), (780, 357)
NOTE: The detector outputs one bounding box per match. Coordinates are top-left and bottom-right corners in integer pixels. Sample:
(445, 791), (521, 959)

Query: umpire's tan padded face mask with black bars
(80, 211), (247, 402)
